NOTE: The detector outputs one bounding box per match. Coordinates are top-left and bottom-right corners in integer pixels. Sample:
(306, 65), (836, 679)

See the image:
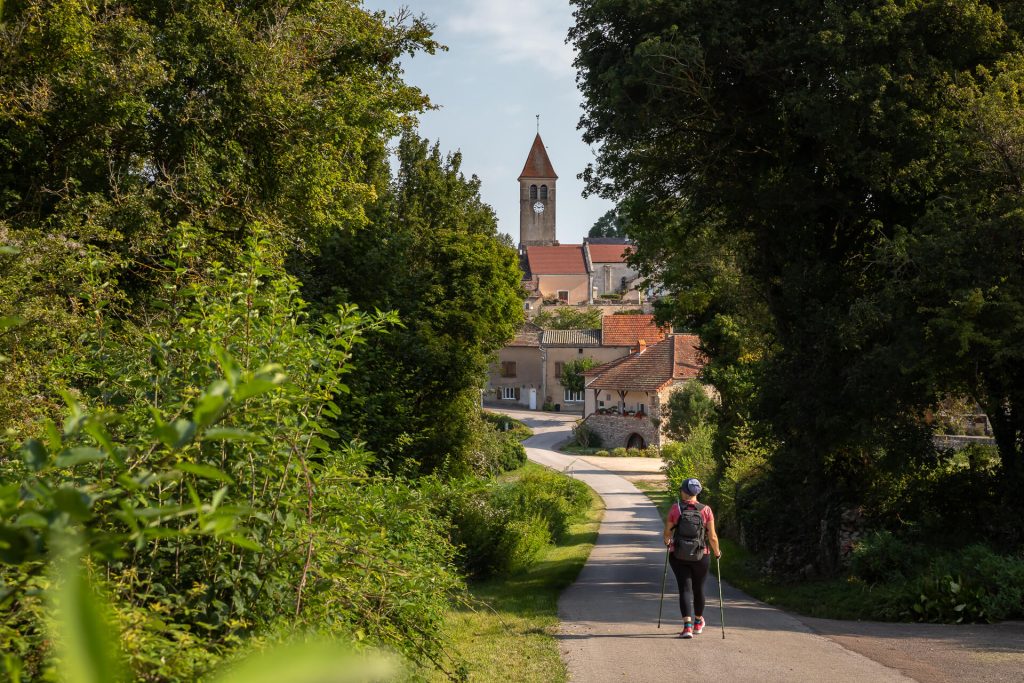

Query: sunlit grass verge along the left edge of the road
(432, 463), (604, 683)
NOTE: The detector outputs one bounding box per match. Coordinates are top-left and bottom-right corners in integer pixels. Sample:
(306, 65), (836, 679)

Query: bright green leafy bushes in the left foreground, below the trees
(0, 236), (460, 681)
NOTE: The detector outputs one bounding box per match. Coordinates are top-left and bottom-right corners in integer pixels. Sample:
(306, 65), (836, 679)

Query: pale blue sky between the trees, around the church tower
(364, 0), (612, 244)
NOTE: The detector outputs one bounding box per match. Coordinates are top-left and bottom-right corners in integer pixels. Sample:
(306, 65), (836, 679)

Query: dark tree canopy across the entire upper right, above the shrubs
(571, 0), (1024, 565)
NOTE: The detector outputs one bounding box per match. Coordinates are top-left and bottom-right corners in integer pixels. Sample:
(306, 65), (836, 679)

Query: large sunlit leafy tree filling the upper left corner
(0, 0), (435, 428)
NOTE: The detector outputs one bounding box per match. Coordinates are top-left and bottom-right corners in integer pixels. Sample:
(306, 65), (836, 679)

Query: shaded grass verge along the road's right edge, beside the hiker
(636, 481), (871, 620)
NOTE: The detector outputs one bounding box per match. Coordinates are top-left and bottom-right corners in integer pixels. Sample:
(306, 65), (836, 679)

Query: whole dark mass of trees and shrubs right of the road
(570, 0), (1024, 622)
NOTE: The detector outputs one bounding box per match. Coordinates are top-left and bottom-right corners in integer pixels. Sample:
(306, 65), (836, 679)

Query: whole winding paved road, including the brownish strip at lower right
(497, 413), (1024, 683)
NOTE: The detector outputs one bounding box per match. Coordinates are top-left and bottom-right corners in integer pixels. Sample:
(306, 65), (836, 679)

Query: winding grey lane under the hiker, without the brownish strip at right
(495, 412), (913, 683)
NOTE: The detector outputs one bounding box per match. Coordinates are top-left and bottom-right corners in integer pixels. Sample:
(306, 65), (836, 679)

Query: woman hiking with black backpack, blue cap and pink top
(665, 478), (722, 638)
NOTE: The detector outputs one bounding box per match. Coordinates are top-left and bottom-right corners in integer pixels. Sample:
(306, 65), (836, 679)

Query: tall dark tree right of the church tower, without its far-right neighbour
(571, 0), (1024, 561)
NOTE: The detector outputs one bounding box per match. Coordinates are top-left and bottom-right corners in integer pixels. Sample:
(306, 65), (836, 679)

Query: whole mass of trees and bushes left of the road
(0, 0), (590, 683)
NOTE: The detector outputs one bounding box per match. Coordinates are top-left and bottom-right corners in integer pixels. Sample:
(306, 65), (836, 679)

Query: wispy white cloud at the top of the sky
(450, 0), (573, 76)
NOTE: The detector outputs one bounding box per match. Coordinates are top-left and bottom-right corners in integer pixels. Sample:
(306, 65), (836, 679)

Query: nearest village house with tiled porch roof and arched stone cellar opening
(584, 334), (703, 449)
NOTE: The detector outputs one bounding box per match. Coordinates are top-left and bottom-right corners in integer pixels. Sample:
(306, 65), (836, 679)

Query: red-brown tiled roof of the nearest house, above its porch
(584, 335), (703, 391)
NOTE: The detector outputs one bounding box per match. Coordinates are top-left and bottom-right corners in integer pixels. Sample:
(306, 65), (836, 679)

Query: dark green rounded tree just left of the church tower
(310, 133), (523, 473)
